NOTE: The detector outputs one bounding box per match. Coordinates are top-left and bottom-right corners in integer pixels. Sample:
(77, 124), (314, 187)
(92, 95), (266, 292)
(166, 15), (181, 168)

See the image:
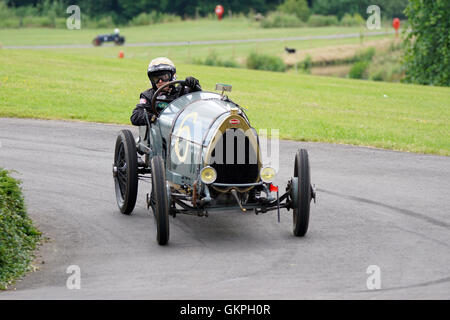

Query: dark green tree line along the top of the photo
(4, 0), (408, 23)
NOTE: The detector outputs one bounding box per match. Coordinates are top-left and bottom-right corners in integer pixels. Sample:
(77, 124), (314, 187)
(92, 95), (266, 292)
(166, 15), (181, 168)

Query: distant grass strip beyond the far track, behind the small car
(0, 19), (384, 46)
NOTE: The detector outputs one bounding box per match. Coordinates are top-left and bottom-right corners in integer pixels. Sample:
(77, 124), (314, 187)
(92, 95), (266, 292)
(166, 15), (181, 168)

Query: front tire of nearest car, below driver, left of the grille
(150, 156), (170, 246)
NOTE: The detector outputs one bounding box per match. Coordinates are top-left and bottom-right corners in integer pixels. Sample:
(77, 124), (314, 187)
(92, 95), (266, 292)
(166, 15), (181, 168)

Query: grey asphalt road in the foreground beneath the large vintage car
(0, 119), (450, 299)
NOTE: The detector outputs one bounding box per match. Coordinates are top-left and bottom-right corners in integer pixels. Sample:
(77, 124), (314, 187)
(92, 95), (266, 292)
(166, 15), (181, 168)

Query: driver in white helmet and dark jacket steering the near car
(130, 57), (202, 126)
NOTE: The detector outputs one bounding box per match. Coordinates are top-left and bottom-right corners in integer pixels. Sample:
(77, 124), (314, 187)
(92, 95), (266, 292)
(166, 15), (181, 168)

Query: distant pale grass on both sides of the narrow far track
(0, 18), (393, 65)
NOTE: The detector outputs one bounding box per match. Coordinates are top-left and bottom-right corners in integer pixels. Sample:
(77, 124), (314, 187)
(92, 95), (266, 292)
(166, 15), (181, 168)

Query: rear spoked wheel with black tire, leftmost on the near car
(113, 130), (138, 214)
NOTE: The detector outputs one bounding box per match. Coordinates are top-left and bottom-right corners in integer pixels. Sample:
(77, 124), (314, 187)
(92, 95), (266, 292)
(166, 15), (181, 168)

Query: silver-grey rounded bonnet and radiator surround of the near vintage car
(140, 91), (261, 191)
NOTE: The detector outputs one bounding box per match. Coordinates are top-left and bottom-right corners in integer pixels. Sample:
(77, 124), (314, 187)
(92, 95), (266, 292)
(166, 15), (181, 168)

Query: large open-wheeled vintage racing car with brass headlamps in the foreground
(113, 81), (315, 245)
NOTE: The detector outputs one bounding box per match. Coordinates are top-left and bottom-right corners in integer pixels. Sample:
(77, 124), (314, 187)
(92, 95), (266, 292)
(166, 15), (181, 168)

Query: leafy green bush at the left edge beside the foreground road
(0, 168), (40, 290)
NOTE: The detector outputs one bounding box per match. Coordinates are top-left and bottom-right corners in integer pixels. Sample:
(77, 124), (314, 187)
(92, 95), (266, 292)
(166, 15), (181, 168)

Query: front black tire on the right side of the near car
(293, 149), (311, 237)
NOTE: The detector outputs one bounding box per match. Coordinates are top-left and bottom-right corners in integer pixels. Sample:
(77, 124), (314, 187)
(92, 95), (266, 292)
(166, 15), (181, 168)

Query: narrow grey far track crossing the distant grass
(3, 31), (395, 49)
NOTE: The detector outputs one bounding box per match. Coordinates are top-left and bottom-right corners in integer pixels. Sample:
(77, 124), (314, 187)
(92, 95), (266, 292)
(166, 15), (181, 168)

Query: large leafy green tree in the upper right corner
(405, 0), (450, 86)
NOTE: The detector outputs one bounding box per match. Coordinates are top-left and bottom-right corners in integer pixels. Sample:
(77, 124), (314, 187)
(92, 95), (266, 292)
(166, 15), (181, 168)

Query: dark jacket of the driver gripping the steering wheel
(130, 85), (202, 126)
